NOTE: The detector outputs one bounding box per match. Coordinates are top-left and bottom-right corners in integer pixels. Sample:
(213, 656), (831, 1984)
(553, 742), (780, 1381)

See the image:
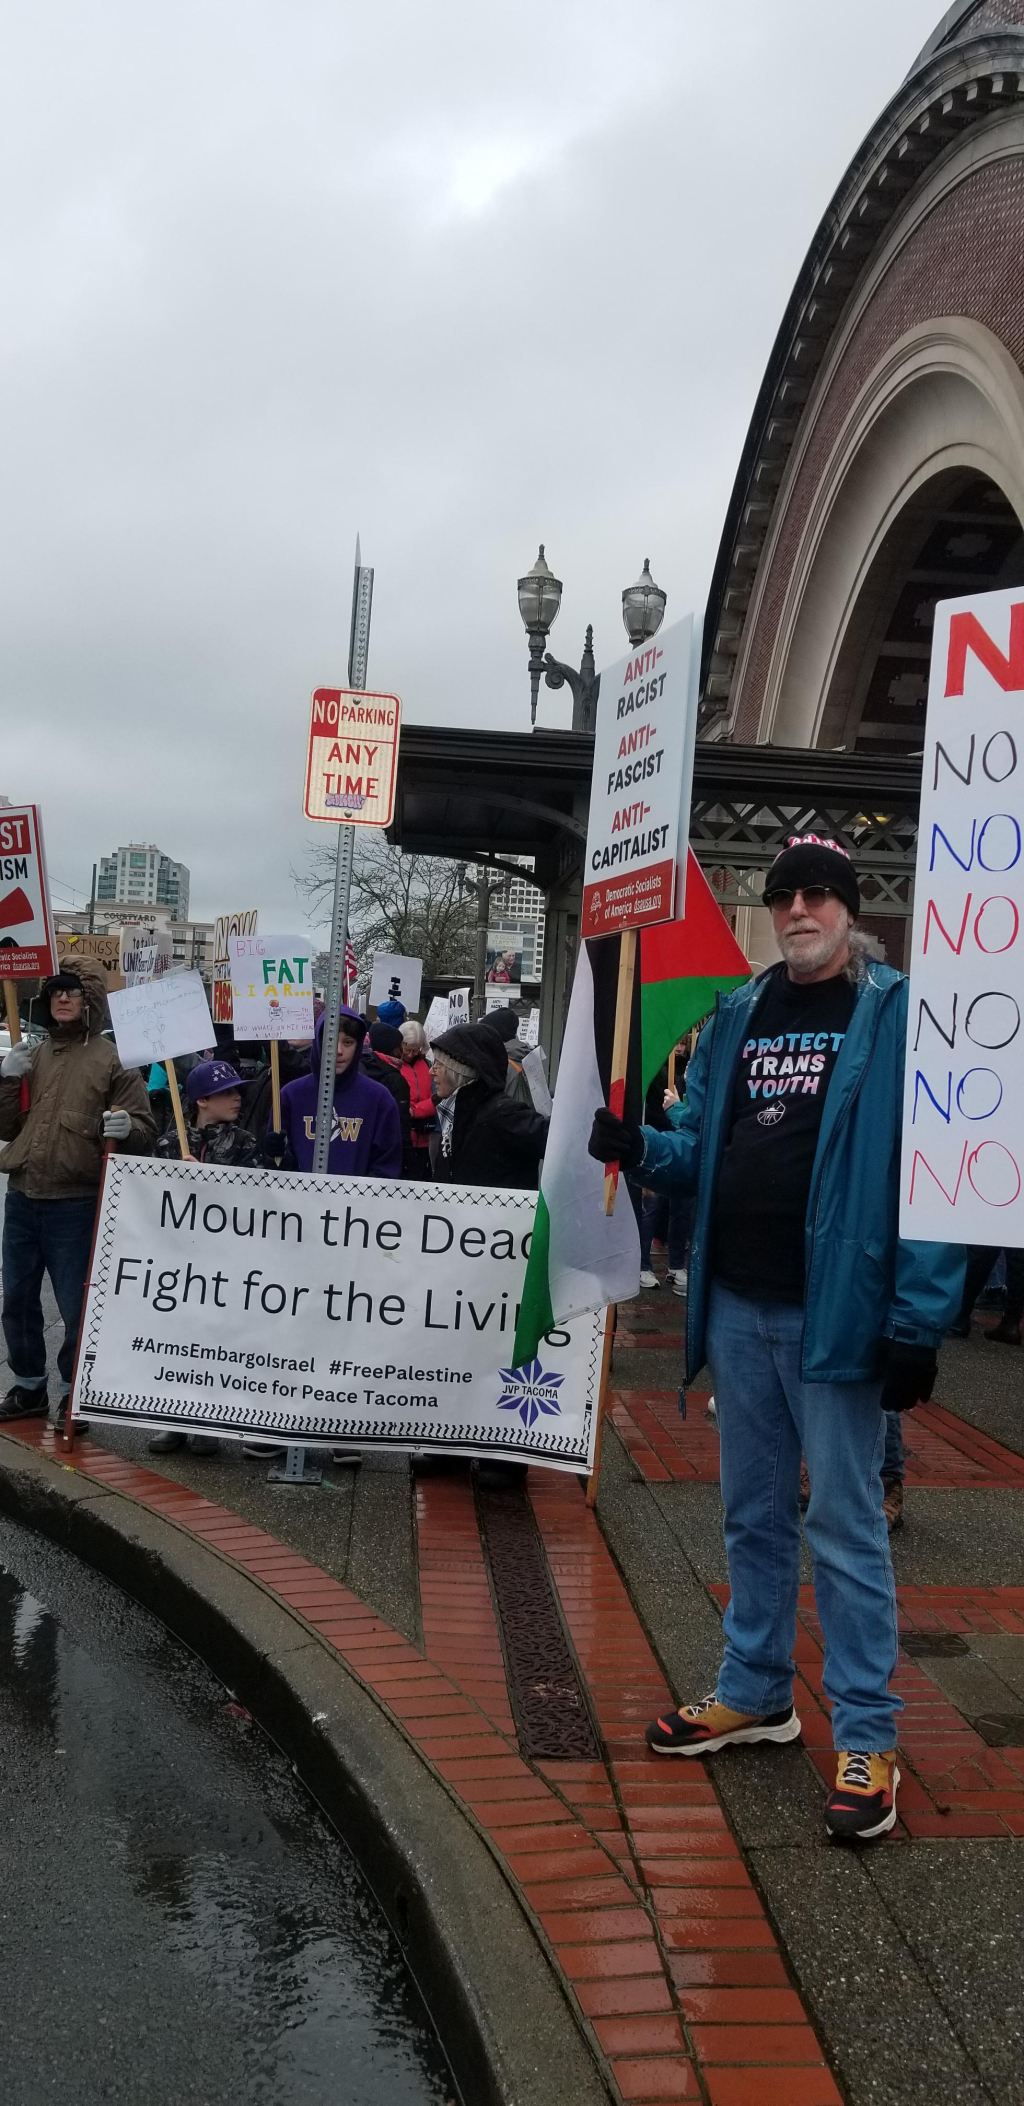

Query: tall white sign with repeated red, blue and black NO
(900, 590), (1024, 1247)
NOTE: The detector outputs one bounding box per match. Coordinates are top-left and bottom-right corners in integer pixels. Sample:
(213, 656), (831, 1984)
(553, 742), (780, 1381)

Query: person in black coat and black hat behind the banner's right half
(430, 1024), (548, 1192)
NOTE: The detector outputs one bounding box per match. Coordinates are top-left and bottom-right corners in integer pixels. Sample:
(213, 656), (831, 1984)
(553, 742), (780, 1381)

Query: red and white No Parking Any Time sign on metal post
(303, 687), (402, 826)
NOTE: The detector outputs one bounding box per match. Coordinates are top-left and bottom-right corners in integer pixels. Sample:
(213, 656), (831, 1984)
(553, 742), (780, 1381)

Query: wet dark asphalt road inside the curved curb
(0, 1521), (453, 2106)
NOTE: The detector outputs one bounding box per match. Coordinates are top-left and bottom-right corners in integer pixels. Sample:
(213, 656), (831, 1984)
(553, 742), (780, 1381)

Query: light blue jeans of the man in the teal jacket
(708, 1283), (902, 1754)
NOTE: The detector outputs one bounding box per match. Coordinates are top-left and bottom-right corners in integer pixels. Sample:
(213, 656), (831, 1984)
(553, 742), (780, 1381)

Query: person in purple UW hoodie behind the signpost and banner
(271, 1009), (402, 1177)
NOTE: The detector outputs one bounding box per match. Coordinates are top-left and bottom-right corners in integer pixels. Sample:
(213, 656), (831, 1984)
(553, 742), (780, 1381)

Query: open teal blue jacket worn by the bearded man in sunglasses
(632, 960), (965, 1382)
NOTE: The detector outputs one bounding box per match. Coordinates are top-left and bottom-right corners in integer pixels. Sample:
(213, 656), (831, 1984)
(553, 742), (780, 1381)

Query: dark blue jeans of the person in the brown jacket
(2, 1186), (97, 1396)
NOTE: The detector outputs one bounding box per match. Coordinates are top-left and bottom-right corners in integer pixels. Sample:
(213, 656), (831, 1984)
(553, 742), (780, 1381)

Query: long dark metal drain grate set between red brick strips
(476, 1485), (600, 1763)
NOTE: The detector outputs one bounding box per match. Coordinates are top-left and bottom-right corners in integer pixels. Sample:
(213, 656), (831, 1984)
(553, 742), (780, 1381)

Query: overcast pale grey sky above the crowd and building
(0, 0), (942, 929)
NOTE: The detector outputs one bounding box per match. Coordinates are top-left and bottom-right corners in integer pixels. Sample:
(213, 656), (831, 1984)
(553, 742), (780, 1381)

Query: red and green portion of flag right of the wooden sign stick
(641, 849), (750, 1091)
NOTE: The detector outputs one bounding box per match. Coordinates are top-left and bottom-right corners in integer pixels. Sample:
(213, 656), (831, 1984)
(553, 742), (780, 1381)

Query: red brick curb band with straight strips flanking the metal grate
(4, 1422), (841, 2106)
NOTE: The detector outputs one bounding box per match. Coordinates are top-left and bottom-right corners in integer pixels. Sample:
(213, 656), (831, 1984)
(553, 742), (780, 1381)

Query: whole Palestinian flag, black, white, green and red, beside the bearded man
(512, 853), (750, 1367)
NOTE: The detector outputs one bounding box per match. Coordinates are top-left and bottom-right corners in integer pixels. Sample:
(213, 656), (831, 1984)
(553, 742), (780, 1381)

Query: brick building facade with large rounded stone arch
(702, 0), (1024, 962)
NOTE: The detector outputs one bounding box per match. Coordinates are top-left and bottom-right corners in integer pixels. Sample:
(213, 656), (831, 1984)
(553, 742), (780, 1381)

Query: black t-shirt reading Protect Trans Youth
(714, 965), (855, 1302)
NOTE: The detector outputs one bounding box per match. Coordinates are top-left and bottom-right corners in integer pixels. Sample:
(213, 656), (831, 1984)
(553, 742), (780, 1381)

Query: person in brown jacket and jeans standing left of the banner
(0, 958), (156, 1419)
